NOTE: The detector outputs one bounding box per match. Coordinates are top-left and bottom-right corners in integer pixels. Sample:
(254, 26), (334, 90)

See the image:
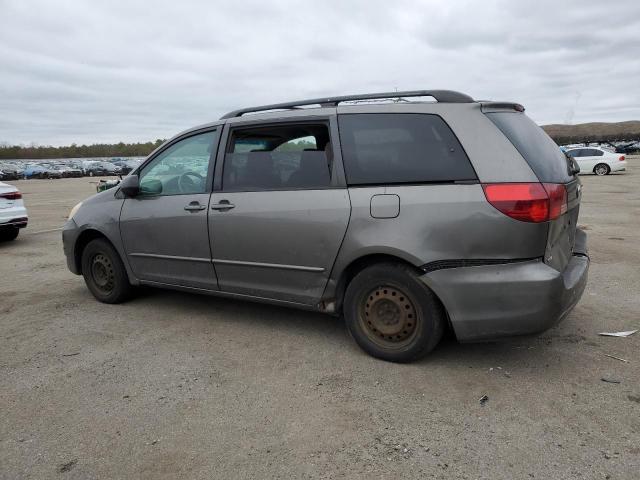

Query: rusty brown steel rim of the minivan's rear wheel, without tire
(358, 285), (418, 349)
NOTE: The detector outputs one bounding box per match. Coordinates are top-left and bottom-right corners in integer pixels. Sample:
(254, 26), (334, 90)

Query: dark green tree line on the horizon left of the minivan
(0, 139), (164, 160)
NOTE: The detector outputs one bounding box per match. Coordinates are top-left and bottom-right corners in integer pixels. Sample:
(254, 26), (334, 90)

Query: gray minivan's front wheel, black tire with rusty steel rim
(82, 238), (133, 303)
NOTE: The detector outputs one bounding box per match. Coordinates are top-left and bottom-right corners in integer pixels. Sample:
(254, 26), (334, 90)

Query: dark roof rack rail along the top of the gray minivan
(220, 90), (474, 120)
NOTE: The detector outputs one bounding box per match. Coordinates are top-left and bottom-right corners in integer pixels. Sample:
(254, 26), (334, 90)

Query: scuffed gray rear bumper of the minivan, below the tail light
(420, 230), (589, 342)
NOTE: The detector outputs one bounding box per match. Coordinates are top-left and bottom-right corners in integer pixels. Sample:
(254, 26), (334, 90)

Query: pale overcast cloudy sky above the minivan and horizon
(0, 0), (640, 145)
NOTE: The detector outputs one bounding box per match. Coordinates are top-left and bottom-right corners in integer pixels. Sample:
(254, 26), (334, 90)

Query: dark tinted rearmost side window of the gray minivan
(338, 113), (476, 185)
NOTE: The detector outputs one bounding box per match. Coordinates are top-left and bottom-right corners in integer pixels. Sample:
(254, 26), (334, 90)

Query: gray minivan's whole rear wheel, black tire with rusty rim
(343, 263), (446, 363)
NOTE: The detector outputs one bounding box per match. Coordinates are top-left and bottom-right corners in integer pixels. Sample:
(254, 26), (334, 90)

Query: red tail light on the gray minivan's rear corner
(482, 183), (567, 223)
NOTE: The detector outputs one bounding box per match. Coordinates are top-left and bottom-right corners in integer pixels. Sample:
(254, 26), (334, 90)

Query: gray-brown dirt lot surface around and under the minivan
(0, 166), (640, 479)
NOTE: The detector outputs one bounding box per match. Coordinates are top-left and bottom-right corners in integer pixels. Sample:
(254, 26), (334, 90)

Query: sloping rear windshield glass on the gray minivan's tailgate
(486, 112), (573, 183)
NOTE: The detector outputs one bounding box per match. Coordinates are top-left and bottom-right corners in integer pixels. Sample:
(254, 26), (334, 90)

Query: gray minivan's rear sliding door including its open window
(209, 120), (350, 305)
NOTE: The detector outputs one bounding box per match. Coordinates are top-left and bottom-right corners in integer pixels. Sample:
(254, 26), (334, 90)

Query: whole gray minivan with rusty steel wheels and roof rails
(63, 90), (589, 362)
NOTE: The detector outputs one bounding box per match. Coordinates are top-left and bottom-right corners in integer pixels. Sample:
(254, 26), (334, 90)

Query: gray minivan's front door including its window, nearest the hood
(120, 130), (218, 290)
